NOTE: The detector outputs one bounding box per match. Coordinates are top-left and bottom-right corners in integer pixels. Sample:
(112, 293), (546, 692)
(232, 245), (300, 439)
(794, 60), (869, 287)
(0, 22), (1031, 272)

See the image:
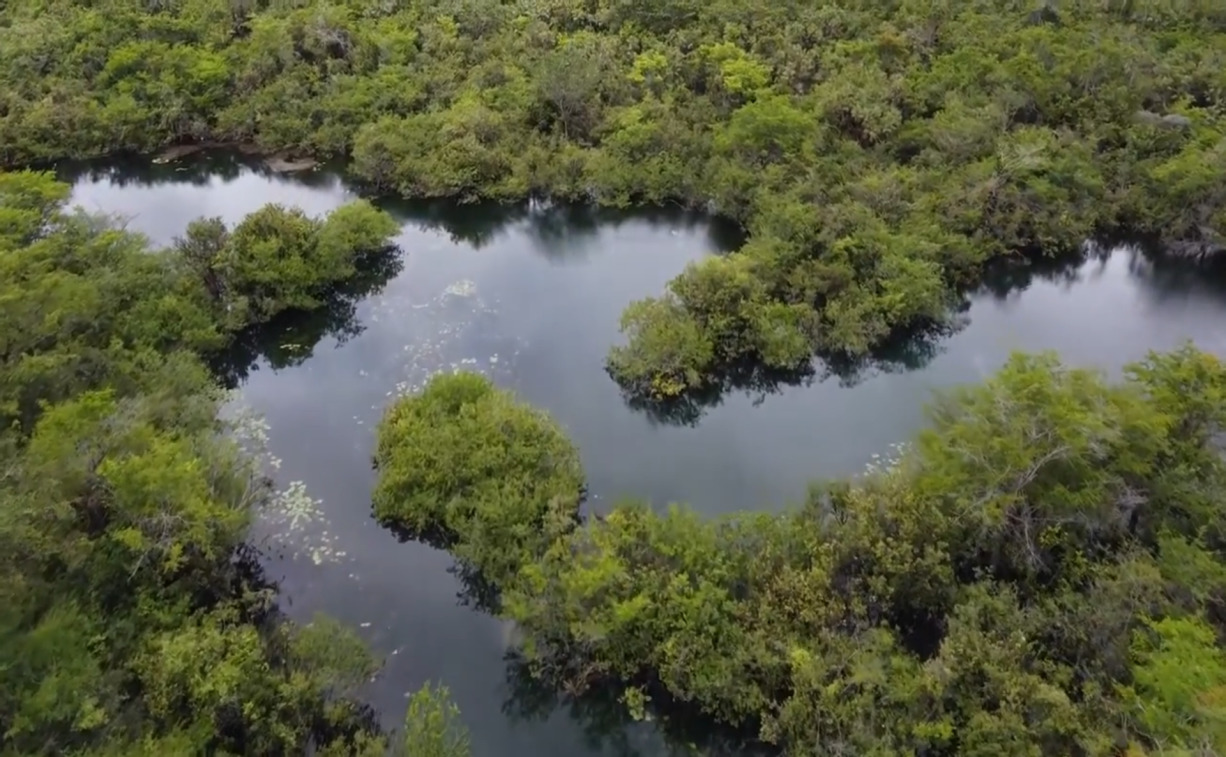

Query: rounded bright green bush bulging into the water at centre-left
(374, 373), (584, 583)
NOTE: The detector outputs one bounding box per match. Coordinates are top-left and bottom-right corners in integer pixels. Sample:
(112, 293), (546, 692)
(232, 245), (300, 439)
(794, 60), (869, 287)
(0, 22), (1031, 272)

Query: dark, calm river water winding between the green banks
(62, 159), (1226, 757)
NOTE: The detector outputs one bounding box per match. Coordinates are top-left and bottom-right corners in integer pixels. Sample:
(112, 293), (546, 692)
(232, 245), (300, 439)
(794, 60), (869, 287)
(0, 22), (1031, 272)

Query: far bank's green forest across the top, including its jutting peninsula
(0, 0), (1226, 398)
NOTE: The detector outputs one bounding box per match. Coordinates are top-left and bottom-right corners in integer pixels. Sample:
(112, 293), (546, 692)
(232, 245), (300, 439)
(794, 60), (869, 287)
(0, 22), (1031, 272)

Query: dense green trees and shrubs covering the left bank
(0, 172), (466, 757)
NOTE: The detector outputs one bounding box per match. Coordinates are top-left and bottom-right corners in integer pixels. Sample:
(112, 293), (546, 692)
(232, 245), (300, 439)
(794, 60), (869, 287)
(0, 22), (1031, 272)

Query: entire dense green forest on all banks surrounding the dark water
(0, 0), (1226, 757)
